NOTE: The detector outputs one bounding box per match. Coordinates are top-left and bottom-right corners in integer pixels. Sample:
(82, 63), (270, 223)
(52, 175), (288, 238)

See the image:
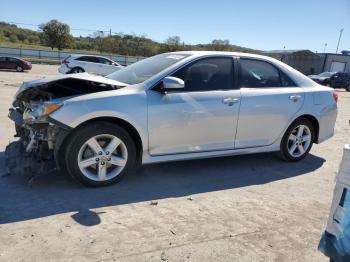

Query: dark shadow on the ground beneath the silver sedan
(0, 152), (325, 226)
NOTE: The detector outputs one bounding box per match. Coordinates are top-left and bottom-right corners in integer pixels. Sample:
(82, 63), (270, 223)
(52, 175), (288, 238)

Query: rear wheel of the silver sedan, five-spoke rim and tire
(280, 118), (315, 162)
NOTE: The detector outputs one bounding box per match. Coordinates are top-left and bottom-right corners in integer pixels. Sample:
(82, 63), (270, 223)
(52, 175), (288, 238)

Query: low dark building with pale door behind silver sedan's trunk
(263, 49), (350, 75)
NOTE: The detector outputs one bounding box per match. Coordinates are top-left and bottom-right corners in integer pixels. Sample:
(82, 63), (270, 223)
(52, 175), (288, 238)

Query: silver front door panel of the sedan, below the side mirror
(147, 90), (240, 155)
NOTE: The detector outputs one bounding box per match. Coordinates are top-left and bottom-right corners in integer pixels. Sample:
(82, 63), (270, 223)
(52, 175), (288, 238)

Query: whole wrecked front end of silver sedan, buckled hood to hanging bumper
(5, 73), (123, 180)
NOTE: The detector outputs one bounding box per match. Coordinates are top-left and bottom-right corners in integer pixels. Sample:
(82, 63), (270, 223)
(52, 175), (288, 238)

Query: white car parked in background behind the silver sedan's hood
(58, 55), (123, 76)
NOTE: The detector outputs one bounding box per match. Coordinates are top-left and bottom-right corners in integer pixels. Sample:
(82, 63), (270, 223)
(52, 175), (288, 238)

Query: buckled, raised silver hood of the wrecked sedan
(15, 73), (127, 97)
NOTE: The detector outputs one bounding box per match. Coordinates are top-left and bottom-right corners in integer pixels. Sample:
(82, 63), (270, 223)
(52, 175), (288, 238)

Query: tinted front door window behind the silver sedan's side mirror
(172, 57), (233, 92)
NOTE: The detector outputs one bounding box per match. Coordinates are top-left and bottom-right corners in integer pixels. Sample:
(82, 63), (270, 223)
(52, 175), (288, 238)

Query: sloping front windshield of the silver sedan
(107, 53), (190, 85)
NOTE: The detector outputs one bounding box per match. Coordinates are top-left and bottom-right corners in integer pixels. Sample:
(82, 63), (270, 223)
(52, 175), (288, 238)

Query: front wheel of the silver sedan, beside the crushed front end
(65, 122), (136, 187)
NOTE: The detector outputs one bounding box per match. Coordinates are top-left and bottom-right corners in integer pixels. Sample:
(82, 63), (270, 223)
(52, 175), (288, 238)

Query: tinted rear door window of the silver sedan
(240, 59), (295, 88)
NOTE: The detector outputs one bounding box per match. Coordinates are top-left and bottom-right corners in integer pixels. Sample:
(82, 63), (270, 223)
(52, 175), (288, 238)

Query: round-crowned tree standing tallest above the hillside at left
(39, 20), (73, 50)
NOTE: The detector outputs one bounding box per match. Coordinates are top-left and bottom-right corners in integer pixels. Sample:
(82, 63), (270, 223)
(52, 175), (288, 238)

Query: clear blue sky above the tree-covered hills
(0, 0), (350, 52)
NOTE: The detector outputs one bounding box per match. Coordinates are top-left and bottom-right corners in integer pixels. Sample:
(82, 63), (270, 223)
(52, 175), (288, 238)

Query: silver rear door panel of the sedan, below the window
(235, 87), (304, 149)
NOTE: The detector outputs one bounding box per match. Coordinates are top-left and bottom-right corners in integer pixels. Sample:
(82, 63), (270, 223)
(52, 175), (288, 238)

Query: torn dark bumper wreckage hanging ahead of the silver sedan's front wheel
(5, 105), (71, 181)
